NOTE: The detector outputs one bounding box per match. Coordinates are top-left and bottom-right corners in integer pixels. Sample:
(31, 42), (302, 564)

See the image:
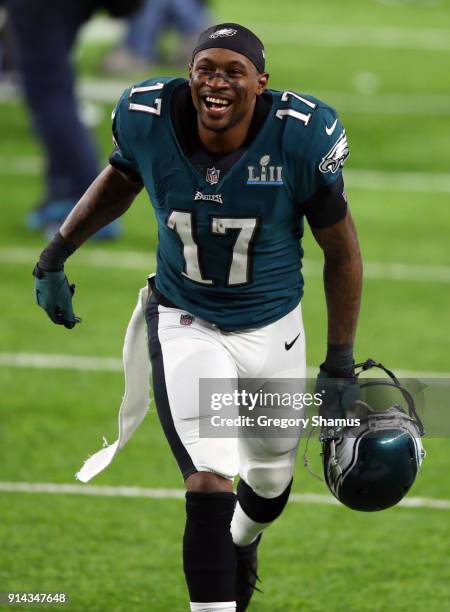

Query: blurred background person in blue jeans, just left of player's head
(102, 0), (211, 75)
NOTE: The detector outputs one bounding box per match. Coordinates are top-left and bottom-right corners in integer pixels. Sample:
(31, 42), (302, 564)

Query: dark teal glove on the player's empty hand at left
(33, 264), (81, 329)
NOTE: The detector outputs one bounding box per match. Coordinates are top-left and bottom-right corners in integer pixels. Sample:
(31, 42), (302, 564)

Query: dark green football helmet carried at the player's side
(321, 359), (425, 512)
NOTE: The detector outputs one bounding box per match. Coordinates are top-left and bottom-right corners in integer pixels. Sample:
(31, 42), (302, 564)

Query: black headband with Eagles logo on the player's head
(192, 23), (266, 72)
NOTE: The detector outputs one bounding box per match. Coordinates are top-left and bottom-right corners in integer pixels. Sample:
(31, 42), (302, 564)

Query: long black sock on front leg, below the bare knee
(183, 491), (236, 602)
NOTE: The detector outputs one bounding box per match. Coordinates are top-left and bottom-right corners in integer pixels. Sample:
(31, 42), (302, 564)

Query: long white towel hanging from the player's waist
(76, 287), (151, 482)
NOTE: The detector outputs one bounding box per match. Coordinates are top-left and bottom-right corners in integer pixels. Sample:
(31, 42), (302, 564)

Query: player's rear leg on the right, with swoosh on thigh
(222, 308), (306, 611)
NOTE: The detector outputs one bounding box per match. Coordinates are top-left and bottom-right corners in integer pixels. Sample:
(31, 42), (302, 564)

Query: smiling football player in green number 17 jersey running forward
(35, 23), (362, 612)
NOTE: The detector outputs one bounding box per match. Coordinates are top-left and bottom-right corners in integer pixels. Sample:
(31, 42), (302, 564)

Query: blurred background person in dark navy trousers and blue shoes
(6, 0), (141, 239)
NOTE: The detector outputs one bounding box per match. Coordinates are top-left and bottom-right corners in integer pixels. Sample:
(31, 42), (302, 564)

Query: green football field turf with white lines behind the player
(0, 0), (450, 612)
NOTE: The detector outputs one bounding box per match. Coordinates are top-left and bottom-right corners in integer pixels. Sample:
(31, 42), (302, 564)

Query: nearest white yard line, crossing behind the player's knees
(0, 482), (450, 510)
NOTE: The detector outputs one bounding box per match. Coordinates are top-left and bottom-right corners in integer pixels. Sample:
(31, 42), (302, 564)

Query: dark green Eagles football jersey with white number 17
(111, 78), (348, 331)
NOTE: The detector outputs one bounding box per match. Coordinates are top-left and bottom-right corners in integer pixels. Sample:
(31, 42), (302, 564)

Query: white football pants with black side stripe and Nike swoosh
(146, 298), (306, 498)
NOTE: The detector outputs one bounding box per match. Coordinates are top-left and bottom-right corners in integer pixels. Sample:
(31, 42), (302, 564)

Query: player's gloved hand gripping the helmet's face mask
(315, 364), (359, 419)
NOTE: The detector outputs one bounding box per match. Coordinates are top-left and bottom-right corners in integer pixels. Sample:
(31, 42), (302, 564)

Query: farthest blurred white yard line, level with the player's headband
(81, 17), (450, 51)
